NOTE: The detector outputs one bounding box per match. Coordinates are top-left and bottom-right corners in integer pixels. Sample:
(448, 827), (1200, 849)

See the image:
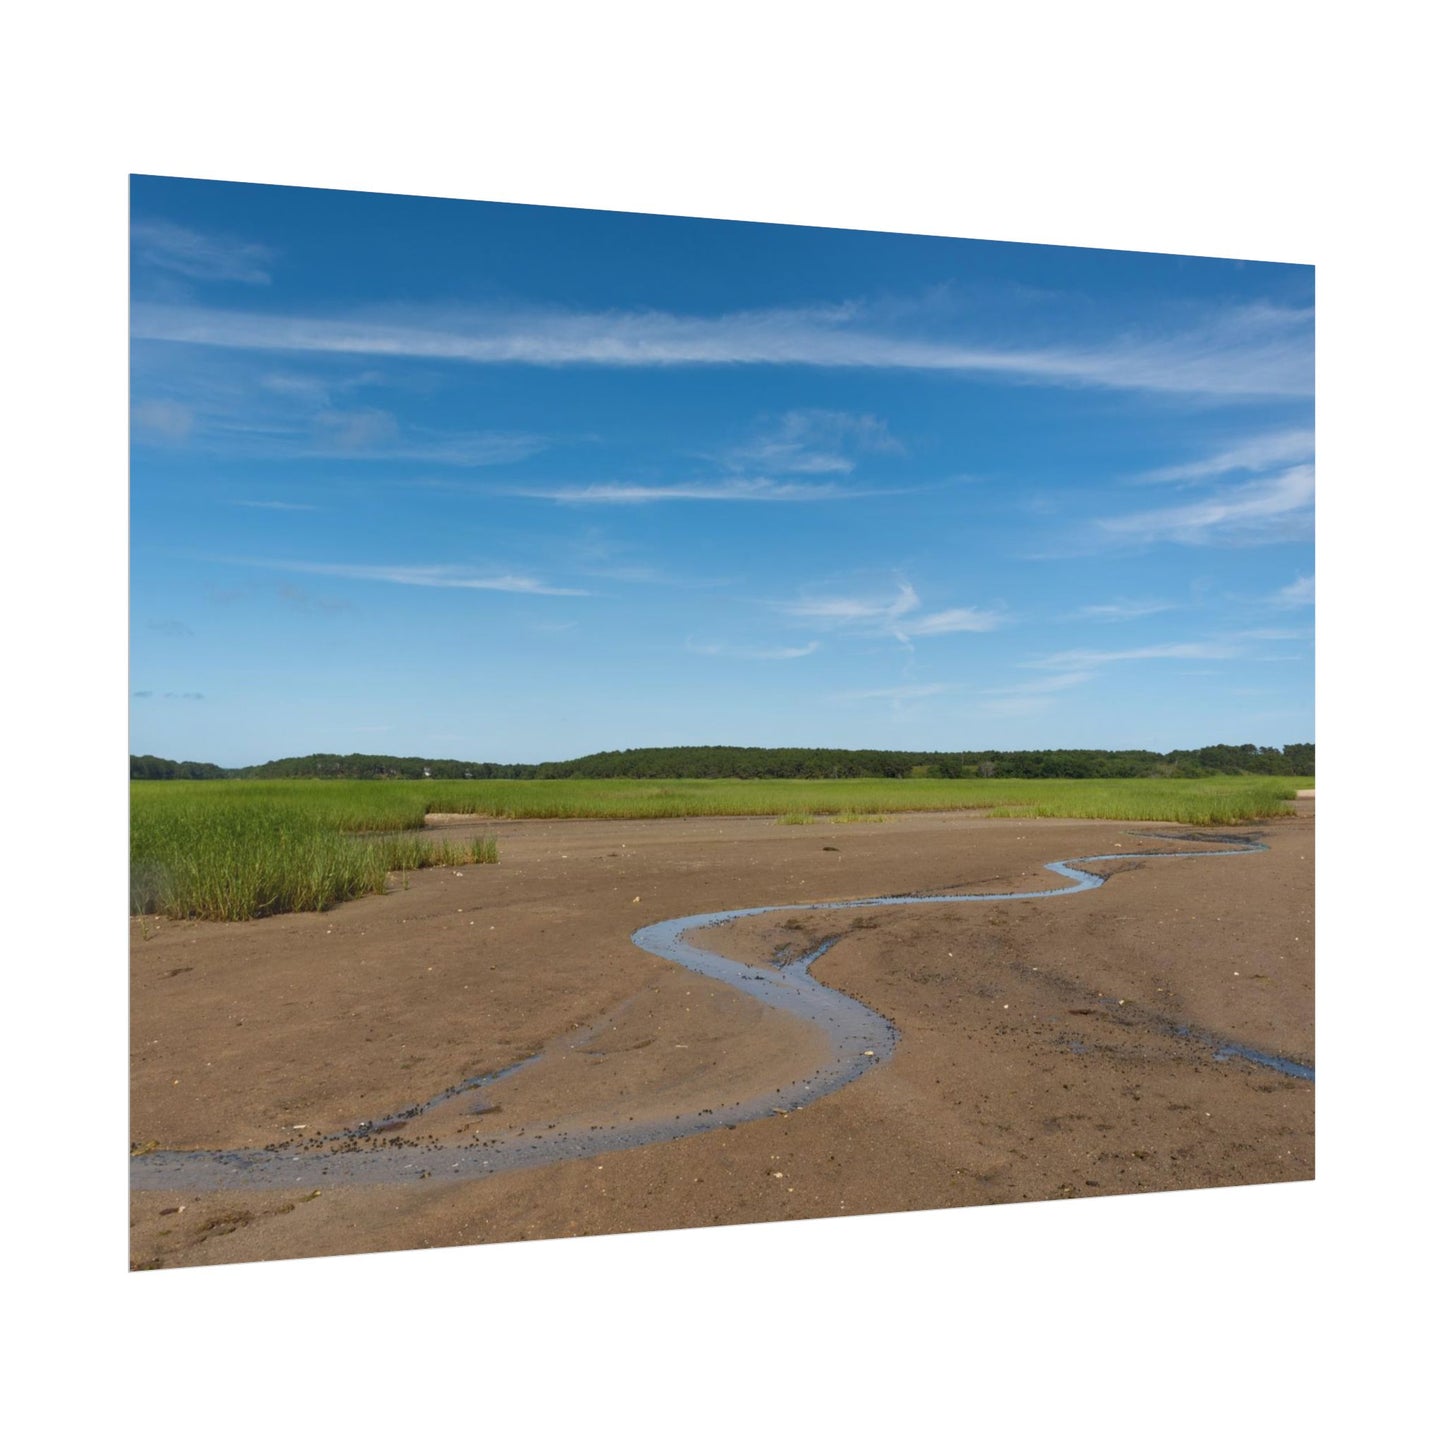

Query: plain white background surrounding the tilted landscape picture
(0, 0), (1441, 1442)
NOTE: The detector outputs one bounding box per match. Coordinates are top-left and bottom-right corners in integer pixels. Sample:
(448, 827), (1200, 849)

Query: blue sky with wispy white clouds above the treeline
(130, 178), (1314, 766)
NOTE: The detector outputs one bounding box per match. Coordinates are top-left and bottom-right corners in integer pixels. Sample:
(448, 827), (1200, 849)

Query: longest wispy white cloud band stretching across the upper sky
(131, 303), (1314, 396)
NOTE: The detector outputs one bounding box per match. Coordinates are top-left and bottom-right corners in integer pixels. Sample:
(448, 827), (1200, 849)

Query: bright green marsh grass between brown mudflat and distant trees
(130, 776), (1314, 919)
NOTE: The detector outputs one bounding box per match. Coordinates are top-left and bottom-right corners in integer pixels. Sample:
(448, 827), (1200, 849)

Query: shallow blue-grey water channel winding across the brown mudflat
(130, 834), (1315, 1189)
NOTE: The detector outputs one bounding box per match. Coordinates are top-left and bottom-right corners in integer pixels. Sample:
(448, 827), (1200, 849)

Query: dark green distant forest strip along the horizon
(130, 743), (1315, 779)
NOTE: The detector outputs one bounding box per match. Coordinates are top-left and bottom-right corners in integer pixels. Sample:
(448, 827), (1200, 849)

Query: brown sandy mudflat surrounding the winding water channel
(130, 801), (1314, 1269)
